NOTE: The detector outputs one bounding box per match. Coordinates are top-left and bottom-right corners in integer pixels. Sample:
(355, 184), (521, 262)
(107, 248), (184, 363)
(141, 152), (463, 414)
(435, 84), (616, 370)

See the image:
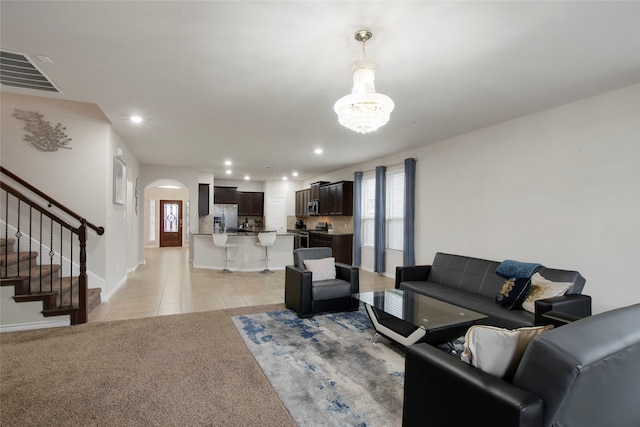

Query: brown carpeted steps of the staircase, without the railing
(0, 238), (101, 324)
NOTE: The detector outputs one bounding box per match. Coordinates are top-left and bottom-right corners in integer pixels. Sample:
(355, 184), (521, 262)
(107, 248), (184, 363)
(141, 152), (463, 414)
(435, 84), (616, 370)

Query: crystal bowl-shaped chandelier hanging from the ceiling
(333, 30), (394, 133)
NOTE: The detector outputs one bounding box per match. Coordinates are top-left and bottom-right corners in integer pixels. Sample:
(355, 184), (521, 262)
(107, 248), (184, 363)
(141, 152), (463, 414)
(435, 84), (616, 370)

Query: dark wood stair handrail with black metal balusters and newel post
(0, 166), (104, 324)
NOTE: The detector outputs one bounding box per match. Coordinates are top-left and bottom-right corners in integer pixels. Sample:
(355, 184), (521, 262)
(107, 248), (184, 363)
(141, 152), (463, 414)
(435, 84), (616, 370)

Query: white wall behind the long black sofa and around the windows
(316, 85), (640, 313)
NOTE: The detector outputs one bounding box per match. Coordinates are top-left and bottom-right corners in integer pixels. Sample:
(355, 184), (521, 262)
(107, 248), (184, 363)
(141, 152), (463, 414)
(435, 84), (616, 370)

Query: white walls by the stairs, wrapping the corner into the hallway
(0, 92), (139, 308)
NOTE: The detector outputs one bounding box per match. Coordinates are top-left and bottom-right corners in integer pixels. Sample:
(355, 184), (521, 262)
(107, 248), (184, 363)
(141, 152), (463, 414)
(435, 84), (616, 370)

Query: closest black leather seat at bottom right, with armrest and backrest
(402, 304), (640, 427)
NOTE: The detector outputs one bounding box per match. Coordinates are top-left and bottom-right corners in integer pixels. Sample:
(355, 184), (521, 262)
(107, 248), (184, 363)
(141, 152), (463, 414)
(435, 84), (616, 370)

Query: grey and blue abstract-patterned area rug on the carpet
(232, 310), (404, 427)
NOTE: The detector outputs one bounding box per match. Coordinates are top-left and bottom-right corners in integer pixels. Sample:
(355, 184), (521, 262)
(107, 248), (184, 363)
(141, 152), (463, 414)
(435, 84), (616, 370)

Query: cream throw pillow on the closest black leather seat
(461, 325), (553, 381)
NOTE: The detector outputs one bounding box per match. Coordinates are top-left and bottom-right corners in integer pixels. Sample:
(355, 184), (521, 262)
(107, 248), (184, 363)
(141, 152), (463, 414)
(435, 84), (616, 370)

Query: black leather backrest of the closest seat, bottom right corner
(513, 304), (640, 426)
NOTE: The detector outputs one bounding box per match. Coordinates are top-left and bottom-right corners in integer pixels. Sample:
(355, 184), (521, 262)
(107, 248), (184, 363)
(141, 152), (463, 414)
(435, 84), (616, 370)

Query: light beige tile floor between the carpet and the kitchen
(89, 247), (394, 322)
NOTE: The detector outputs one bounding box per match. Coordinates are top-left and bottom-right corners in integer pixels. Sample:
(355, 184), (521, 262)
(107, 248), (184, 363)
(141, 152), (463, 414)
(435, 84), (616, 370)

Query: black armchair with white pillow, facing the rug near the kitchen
(284, 248), (360, 317)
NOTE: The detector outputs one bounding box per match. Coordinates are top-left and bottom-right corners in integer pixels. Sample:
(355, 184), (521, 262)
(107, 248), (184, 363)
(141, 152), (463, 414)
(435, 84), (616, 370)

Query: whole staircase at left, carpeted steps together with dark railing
(0, 166), (104, 325)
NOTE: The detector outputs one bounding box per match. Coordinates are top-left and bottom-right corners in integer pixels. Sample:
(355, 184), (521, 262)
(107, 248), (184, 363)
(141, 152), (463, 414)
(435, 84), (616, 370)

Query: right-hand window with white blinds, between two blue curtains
(385, 168), (404, 251)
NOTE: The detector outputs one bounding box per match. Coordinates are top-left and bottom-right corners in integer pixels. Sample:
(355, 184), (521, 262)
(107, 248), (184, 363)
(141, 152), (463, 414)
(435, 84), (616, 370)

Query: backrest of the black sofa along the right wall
(429, 252), (585, 298)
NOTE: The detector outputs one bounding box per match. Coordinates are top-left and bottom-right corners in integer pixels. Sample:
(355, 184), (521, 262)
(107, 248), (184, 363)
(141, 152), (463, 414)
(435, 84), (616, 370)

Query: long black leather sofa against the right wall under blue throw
(395, 252), (591, 329)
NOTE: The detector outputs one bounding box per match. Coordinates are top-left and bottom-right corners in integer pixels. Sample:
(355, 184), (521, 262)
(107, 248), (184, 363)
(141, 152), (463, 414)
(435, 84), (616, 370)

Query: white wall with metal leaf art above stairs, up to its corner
(0, 92), (109, 278)
